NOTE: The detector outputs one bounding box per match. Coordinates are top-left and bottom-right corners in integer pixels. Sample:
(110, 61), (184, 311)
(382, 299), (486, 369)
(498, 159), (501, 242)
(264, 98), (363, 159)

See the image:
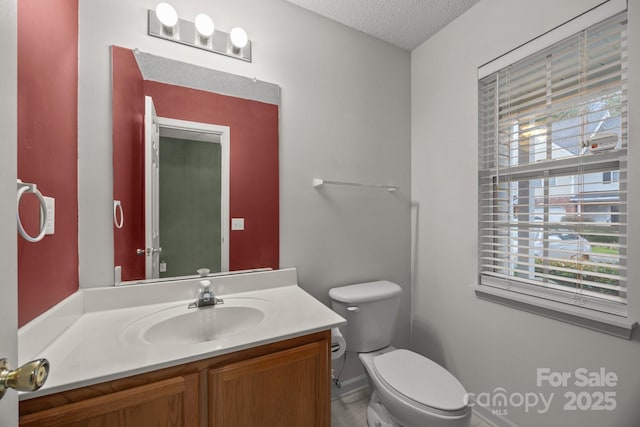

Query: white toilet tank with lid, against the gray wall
(329, 280), (402, 353)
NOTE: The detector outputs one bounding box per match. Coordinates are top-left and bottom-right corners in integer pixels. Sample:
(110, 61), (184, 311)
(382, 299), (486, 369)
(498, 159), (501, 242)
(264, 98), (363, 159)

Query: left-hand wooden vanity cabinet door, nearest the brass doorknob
(20, 374), (198, 427)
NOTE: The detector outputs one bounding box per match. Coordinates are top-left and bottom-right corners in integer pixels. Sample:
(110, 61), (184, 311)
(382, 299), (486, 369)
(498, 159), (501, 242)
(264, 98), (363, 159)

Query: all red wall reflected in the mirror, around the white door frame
(113, 48), (280, 280)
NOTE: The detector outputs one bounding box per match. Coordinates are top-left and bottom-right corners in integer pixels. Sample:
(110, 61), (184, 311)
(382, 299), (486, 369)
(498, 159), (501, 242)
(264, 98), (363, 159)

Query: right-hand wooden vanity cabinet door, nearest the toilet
(209, 341), (331, 427)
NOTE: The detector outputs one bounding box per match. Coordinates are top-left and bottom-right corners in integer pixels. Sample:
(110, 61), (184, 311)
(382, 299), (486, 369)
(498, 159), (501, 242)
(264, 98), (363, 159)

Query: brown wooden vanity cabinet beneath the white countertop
(20, 331), (331, 427)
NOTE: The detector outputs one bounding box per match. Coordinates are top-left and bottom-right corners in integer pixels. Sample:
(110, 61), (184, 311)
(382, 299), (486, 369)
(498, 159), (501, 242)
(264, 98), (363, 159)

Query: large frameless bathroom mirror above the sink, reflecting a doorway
(111, 46), (280, 283)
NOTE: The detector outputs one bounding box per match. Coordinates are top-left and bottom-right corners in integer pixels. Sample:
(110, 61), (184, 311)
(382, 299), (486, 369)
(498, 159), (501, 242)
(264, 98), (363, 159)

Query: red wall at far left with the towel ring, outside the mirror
(17, 0), (78, 326)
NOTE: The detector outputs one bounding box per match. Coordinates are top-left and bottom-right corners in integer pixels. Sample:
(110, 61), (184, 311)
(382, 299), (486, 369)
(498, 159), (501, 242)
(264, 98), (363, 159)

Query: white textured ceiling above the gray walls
(287, 0), (479, 51)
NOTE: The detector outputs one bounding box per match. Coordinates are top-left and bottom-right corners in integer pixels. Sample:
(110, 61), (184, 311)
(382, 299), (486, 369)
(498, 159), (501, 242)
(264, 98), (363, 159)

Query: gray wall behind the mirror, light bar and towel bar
(78, 0), (411, 380)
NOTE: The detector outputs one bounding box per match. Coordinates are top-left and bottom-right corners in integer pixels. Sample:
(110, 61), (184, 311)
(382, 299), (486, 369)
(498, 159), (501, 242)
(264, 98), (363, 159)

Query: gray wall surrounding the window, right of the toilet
(411, 0), (640, 427)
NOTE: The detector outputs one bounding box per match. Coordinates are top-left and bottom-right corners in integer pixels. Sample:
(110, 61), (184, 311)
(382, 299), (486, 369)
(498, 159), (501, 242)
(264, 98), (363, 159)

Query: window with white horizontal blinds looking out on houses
(478, 5), (628, 336)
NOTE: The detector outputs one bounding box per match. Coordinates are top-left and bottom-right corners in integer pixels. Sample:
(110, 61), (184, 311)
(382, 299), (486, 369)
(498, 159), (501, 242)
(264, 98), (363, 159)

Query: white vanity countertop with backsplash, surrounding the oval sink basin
(18, 269), (345, 400)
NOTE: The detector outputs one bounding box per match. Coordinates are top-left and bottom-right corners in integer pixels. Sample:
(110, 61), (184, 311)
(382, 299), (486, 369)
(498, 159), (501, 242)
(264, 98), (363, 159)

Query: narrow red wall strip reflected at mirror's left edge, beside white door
(111, 46), (145, 280)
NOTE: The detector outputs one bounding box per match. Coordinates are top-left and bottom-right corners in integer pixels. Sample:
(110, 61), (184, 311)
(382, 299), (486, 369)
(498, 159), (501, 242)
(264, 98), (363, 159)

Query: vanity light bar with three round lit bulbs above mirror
(148, 3), (251, 62)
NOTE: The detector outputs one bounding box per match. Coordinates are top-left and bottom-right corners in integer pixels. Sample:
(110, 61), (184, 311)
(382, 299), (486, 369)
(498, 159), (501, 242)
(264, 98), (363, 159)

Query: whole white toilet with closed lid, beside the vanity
(329, 281), (471, 427)
